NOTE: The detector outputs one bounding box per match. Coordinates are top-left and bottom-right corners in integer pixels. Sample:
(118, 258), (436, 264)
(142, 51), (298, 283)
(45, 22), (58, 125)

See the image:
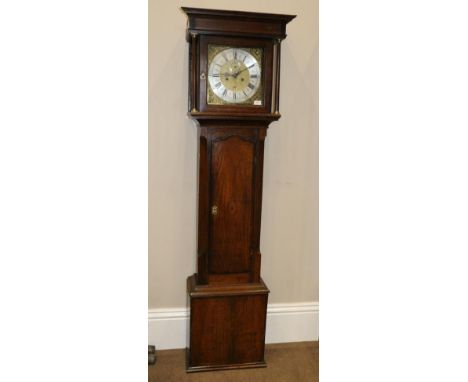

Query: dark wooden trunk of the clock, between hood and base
(194, 121), (268, 284)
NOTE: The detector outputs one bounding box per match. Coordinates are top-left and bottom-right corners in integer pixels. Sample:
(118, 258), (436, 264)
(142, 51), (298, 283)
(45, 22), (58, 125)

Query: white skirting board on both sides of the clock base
(148, 302), (319, 350)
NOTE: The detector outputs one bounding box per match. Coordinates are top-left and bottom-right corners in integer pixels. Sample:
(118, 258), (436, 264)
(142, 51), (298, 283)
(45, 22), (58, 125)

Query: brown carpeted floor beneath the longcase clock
(148, 342), (319, 382)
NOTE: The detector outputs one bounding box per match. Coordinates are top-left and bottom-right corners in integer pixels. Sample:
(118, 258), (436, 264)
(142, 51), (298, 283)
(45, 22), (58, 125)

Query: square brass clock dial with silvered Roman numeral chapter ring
(207, 47), (262, 105)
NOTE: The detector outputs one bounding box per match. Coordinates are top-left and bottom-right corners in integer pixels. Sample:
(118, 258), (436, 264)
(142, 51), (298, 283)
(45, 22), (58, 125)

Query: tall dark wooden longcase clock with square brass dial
(182, 7), (295, 372)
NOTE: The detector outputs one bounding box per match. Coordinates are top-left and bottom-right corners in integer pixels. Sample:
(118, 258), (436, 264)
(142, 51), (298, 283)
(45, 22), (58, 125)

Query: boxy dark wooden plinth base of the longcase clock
(187, 275), (270, 372)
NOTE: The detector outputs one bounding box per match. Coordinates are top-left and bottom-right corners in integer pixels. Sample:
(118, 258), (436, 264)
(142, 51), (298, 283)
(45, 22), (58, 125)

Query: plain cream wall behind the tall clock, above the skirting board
(148, 0), (319, 309)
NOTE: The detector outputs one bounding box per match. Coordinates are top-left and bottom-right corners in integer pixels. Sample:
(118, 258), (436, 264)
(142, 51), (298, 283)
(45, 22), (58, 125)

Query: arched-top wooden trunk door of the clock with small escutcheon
(210, 135), (255, 274)
